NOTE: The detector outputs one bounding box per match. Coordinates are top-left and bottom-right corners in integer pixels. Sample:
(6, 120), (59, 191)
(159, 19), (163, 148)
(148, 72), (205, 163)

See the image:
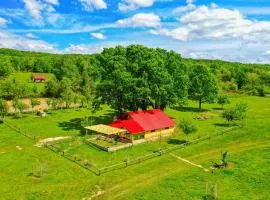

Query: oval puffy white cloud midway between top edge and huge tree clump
(117, 13), (161, 27)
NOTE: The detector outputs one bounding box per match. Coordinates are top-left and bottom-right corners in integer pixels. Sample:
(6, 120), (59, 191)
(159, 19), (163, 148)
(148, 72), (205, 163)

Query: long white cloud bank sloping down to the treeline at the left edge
(0, 31), (60, 53)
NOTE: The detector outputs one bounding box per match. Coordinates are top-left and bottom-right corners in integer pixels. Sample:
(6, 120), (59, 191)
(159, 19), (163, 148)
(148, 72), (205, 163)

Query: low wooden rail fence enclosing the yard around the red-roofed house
(2, 121), (240, 176)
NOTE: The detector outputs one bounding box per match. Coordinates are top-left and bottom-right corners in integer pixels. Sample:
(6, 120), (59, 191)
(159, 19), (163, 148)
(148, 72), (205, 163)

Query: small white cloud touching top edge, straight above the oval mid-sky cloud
(118, 0), (155, 11)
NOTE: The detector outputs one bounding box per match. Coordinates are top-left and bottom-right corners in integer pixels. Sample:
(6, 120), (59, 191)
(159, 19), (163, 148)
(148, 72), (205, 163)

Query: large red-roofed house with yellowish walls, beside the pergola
(109, 109), (176, 142)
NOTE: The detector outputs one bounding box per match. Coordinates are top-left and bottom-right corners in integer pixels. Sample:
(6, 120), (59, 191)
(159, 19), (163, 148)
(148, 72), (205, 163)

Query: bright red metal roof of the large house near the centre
(109, 109), (175, 134)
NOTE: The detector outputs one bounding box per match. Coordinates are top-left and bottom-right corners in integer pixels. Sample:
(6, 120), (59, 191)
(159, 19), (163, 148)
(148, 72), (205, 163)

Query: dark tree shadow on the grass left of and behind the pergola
(58, 112), (115, 135)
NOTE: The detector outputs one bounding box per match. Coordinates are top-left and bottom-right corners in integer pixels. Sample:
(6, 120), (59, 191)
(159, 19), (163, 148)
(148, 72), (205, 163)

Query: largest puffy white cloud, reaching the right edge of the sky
(152, 6), (270, 41)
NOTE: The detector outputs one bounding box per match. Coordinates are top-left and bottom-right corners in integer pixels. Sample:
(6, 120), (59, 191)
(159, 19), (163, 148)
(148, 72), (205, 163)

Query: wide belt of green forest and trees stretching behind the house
(0, 45), (270, 113)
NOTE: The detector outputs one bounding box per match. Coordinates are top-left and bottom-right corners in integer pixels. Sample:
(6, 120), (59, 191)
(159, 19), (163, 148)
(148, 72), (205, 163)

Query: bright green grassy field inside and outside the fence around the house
(0, 96), (270, 200)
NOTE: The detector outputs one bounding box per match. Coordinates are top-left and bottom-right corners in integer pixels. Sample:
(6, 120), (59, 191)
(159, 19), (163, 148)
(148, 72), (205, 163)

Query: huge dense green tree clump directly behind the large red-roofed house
(97, 45), (188, 114)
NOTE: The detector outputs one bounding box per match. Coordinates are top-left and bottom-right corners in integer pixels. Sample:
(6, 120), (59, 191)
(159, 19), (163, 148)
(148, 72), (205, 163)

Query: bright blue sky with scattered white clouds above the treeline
(0, 0), (270, 63)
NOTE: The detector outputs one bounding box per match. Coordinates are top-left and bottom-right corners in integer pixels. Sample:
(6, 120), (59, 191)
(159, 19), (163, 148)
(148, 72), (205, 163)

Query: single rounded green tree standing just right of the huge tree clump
(189, 65), (218, 110)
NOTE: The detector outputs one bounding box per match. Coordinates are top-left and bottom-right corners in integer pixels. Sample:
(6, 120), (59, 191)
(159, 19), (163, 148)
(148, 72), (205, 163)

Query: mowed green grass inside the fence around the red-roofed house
(3, 98), (228, 167)
